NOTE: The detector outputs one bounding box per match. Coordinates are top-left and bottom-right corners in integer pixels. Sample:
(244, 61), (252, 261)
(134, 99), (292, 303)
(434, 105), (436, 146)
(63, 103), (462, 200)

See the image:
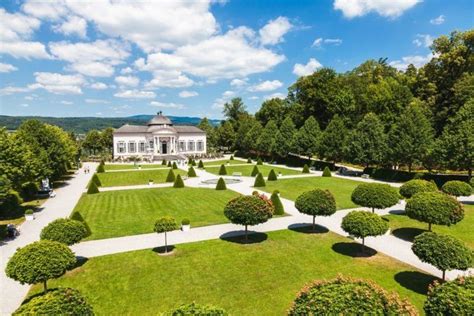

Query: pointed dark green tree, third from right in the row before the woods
(348, 113), (388, 167)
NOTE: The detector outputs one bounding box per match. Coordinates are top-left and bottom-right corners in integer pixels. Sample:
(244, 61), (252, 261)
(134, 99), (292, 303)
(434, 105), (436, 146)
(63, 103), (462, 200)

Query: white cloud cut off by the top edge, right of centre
(333, 0), (421, 19)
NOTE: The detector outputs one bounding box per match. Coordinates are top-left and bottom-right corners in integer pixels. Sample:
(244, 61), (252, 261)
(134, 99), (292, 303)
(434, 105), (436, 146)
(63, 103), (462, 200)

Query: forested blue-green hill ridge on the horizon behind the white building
(0, 114), (220, 134)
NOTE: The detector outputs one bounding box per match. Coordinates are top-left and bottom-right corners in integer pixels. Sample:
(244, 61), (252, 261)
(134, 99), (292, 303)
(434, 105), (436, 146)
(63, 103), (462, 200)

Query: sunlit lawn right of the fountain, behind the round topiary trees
(261, 177), (360, 210)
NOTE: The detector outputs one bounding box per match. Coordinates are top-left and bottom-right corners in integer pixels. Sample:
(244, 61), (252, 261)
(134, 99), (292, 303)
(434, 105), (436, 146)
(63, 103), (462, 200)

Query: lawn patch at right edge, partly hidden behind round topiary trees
(384, 204), (474, 249)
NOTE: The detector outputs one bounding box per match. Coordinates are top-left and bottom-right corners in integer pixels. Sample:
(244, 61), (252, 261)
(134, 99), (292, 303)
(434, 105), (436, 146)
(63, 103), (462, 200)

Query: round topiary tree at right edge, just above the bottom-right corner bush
(411, 232), (473, 280)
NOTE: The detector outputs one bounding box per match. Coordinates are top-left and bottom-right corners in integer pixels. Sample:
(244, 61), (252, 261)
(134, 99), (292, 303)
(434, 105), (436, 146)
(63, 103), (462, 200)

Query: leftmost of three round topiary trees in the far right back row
(351, 183), (400, 213)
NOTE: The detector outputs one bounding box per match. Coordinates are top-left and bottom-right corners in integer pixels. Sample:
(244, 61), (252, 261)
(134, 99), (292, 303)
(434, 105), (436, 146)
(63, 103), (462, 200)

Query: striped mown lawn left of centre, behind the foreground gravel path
(74, 188), (238, 239)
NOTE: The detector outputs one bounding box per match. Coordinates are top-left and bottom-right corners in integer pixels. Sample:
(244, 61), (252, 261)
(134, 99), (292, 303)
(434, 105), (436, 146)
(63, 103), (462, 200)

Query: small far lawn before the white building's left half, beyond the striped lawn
(97, 168), (186, 187)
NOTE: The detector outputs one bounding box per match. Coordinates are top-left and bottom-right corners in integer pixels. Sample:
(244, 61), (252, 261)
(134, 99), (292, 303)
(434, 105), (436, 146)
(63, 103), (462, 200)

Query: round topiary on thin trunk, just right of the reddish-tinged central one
(295, 189), (336, 231)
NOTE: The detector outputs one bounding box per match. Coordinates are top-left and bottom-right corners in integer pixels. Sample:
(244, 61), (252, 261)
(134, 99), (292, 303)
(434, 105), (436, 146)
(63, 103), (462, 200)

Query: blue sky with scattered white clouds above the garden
(0, 0), (474, 118)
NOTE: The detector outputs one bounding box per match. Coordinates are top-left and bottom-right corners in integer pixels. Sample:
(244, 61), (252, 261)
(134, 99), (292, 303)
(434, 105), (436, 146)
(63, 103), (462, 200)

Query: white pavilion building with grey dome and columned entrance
(113, 112), (207, 161)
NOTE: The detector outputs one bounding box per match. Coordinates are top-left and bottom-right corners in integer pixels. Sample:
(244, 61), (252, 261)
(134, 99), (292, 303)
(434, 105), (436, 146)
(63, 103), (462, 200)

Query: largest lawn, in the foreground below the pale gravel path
(32, 230), (433, 316)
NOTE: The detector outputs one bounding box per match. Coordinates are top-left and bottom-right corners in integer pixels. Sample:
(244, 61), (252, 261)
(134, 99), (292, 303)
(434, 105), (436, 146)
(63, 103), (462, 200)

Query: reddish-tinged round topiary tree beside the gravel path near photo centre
(224, 195), (273, 241)
